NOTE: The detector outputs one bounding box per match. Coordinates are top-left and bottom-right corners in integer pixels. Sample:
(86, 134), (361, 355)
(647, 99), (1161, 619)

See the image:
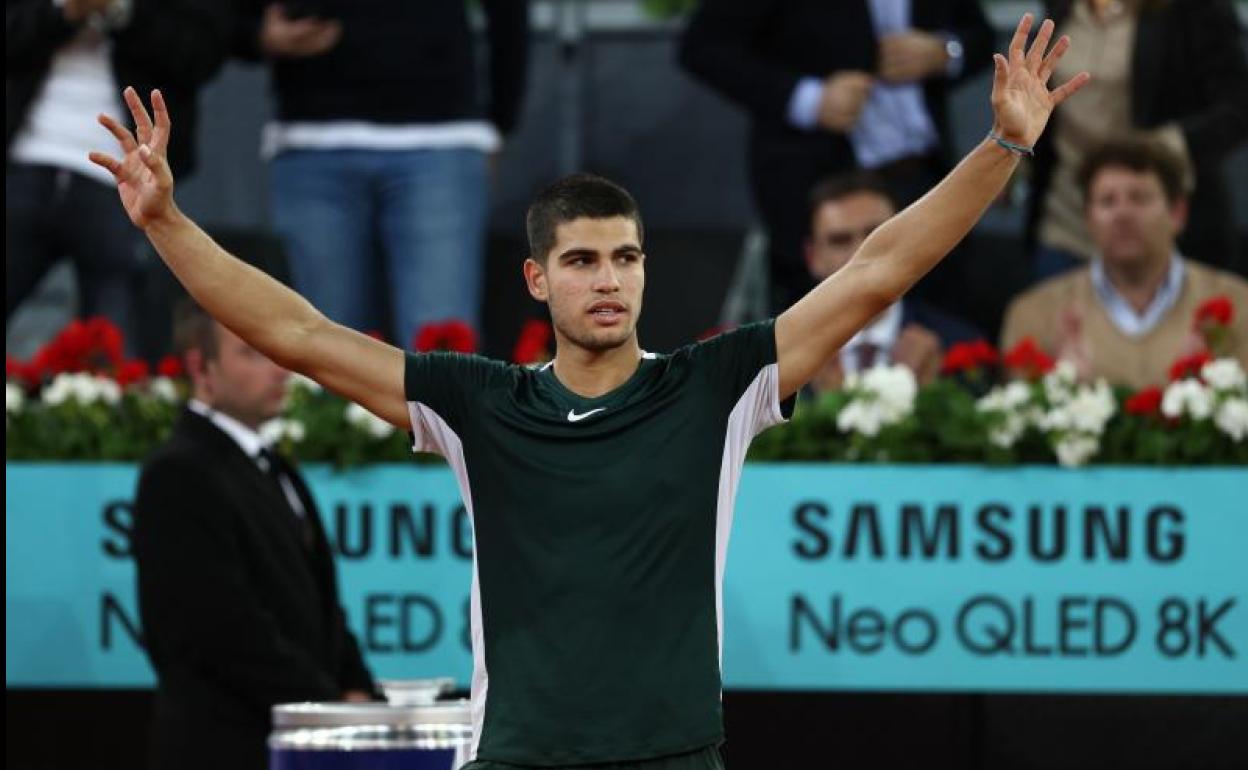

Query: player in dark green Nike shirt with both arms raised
(91, 15), (1087, 770)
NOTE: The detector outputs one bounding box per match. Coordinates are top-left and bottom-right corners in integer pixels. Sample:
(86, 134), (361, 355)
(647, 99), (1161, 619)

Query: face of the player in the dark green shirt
(524, 217), (645, 352)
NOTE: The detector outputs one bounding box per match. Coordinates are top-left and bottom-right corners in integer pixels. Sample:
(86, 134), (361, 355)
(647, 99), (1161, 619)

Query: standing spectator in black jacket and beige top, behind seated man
(1028, 0), (1248, 278)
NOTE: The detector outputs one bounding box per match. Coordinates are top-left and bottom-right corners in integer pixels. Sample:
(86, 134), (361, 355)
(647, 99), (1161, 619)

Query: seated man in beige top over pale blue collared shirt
(1001, 140), (1248, 388)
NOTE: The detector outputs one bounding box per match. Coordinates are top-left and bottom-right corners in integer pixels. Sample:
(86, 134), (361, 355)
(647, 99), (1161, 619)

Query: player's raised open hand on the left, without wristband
(87, 87), (176, 230)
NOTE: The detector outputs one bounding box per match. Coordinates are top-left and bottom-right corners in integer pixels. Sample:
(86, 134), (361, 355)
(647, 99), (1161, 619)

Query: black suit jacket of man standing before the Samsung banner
(134, 411), (374, 770)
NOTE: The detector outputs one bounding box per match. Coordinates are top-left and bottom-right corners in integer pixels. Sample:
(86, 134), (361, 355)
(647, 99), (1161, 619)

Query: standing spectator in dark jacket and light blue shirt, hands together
(680, 0), (993, 311)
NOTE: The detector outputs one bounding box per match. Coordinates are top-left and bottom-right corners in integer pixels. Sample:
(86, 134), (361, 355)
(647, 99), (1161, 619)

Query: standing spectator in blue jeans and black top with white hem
(237, 0), (528, 346)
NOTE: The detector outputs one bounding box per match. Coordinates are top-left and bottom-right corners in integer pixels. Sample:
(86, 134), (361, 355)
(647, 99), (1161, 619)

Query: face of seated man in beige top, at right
(1087, 166), (1186, 267)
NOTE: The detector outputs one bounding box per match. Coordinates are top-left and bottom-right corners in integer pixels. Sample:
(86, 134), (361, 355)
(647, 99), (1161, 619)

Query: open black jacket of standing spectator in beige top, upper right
(1027, 0), (1248, 275)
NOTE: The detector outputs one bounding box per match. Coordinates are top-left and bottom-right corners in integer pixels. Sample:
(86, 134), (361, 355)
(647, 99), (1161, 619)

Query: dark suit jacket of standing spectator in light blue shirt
(680, 0), (993, 309)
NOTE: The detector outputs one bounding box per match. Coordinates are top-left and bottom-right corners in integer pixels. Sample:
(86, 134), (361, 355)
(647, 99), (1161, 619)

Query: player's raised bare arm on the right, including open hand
(776, 14), (1088, 398)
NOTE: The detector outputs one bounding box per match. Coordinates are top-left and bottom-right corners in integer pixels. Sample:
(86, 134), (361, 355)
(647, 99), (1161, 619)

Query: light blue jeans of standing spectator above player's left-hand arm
(272, 149), (487, 346)
